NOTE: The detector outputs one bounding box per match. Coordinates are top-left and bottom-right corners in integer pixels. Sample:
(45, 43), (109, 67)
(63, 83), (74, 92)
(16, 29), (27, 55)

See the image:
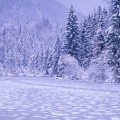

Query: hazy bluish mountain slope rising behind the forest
(0, 0), (84, 23)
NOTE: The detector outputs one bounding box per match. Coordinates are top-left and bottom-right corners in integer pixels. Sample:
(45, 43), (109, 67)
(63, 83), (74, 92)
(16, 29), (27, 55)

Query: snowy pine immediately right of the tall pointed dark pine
(78, 18), (92, 69)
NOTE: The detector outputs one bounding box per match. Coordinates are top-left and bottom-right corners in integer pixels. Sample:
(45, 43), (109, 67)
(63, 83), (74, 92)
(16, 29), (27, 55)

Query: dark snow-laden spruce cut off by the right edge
(106, 0), (120, 82)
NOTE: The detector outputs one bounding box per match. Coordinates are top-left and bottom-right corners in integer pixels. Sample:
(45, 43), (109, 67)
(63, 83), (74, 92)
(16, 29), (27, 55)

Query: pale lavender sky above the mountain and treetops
(58, 0), (106, 15)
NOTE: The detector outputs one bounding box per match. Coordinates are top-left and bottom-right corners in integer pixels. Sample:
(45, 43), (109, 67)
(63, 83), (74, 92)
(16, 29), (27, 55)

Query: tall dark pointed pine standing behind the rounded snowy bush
(64, 5), (79, 58)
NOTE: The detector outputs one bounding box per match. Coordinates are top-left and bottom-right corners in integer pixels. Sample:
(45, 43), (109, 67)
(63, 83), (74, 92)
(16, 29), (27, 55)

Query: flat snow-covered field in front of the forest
(0, 77), (120, 120)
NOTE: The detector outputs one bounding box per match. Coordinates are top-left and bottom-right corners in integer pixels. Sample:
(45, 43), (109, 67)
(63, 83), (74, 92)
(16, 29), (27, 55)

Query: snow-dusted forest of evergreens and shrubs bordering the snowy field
(0, 0), (120, 82)
